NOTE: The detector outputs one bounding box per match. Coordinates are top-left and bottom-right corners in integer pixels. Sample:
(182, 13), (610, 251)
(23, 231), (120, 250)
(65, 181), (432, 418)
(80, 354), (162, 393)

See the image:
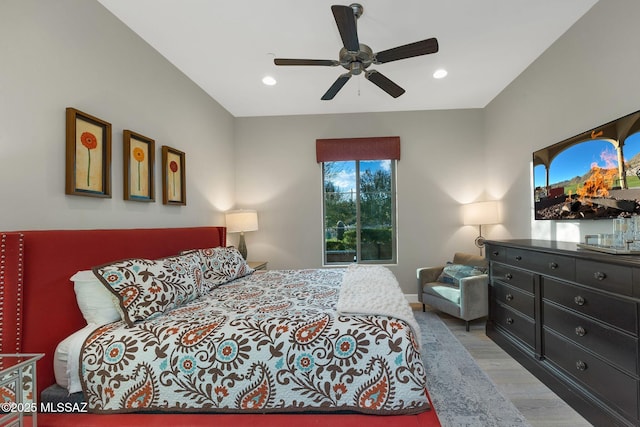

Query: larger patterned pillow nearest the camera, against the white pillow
(93, 254), (202, 326)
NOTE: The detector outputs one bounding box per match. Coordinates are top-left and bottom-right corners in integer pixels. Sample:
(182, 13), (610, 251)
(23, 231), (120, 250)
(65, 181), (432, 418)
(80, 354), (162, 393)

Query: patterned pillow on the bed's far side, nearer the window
(183, 246), (254, 292)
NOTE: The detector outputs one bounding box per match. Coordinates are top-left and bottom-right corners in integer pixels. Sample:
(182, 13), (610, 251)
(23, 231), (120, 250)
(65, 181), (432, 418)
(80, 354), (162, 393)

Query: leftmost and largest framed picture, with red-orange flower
(65, 107), (111, 198)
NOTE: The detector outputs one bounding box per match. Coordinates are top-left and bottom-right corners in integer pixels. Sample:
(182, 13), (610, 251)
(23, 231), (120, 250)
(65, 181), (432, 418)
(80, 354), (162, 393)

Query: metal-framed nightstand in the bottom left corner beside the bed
(0, 354), (44, 427)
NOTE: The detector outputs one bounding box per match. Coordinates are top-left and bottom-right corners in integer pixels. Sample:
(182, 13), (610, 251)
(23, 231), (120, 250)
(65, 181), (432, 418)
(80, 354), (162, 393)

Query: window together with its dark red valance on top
(316, 136), (400, 264)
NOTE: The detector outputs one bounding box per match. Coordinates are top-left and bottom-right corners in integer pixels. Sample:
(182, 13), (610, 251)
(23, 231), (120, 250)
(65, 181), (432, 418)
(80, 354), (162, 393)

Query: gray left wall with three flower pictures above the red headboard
(0, 0), (234, 230)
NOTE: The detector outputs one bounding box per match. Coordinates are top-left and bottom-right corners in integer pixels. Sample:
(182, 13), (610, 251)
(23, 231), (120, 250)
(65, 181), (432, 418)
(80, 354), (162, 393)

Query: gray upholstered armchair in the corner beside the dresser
(416, 252), (489, 331)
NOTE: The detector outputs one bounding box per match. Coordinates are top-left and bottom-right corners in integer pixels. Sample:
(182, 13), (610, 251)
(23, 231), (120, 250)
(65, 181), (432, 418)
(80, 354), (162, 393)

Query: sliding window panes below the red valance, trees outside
(322, 159), (396, 264)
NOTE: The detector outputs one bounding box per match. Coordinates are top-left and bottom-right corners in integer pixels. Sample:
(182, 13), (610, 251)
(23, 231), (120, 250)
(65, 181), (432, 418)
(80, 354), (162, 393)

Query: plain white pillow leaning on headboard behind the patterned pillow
(71, 270), (123, 326)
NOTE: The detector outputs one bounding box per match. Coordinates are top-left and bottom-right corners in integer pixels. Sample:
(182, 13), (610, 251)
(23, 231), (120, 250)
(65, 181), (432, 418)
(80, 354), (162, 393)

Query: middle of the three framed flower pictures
(122, 129), (156, 202)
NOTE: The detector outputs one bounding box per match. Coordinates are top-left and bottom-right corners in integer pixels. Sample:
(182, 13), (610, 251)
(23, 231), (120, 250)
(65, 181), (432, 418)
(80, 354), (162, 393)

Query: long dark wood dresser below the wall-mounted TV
(485, 240), (640, 426)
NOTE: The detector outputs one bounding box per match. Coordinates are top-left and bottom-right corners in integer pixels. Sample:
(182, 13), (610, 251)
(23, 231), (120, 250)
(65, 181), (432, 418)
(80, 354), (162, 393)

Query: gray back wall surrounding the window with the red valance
(235, 110), (485, 294)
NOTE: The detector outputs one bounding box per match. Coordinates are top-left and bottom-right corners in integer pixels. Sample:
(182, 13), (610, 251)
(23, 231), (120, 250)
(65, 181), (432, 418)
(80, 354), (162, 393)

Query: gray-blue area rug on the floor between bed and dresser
(414, 311), (530, 427)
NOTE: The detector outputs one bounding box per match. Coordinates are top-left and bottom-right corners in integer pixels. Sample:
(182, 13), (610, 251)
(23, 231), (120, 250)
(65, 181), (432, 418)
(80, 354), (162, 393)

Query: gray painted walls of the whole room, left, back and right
(0, 0), (640, 294)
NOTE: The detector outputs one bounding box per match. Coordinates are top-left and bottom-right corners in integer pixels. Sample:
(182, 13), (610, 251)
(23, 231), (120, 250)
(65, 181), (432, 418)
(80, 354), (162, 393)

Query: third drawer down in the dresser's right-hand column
(542, 301), (638, 374)
